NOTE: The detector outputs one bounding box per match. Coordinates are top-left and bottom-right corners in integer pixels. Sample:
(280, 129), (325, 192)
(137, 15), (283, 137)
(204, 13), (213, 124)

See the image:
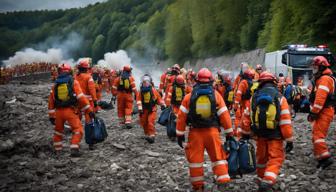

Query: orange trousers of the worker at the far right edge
(312, 107), (334, 160)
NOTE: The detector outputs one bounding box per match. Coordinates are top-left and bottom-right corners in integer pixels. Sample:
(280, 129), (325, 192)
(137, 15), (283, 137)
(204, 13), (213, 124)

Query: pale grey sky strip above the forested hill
(0, 0), (107, 12)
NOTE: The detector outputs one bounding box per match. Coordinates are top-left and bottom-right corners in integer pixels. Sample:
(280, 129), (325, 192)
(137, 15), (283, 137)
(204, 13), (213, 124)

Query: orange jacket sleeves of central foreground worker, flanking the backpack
(176, 91), (233, 136)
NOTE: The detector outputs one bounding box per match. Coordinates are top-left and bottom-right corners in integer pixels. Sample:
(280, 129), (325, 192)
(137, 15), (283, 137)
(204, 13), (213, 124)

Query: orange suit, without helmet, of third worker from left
(112, 73), (137, 125)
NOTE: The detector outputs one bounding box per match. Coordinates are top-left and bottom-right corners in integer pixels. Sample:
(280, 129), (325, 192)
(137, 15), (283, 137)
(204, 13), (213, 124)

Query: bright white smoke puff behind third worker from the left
(98, 50), (162, 86)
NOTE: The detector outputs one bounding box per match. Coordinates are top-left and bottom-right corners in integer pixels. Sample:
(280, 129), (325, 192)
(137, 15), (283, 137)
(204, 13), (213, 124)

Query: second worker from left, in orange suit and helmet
(75, 59), (98, 123)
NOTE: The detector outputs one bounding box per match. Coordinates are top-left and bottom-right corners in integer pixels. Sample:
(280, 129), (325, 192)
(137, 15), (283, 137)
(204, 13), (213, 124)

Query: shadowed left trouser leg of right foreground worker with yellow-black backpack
(256, 138), (267, 178)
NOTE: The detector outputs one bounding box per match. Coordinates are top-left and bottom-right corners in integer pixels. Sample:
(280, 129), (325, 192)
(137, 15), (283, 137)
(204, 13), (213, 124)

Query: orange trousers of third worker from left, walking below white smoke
(117, 91), (133, 125)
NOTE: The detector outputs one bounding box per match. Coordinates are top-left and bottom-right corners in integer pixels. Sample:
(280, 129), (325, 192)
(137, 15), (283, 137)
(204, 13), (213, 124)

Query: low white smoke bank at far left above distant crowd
(3, 48), (63, 67)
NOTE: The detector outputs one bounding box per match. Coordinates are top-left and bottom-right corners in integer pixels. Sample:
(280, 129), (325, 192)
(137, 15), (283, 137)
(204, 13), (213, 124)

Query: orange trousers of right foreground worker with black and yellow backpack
(256, 138), (285, 185)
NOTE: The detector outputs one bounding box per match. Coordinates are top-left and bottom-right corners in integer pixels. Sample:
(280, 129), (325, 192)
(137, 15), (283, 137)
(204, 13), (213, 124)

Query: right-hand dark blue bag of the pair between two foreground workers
(239, 139), (256, 174)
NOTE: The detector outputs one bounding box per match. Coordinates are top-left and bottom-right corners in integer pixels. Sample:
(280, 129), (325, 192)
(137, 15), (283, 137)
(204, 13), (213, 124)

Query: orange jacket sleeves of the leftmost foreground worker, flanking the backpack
(48, 80), (92, 118)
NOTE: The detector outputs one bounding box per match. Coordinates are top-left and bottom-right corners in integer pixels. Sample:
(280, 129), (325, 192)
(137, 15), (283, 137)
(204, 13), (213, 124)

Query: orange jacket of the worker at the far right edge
(310, 69), (335, 113)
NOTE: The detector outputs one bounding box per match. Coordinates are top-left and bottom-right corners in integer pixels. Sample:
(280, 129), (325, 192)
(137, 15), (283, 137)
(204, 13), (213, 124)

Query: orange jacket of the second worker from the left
(76, 73), (97, 101)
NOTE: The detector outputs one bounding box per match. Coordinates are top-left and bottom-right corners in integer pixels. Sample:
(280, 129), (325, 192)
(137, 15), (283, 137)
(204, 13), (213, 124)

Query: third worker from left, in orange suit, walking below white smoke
(112, 65), (137, 129)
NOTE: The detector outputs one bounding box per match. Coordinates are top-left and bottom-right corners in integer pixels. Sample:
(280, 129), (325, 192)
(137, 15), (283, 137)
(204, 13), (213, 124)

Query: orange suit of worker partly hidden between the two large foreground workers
(234, 79), (251, 138)
